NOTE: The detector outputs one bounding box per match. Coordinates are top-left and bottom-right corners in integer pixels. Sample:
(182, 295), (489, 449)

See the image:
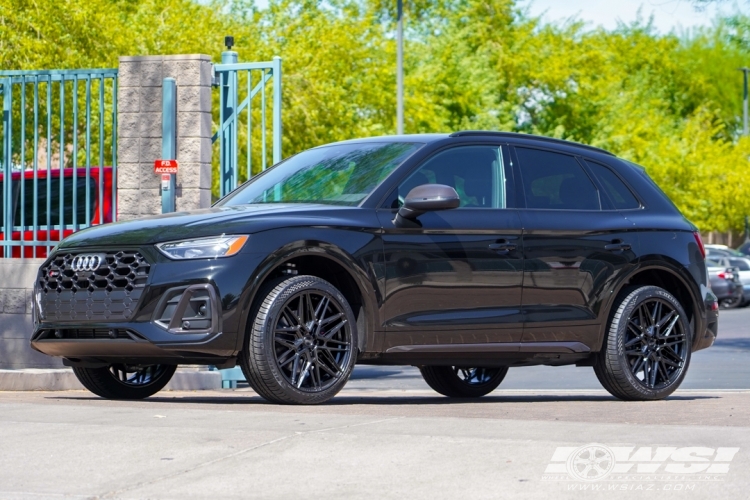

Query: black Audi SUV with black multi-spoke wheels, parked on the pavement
(31, 131), (718, 404)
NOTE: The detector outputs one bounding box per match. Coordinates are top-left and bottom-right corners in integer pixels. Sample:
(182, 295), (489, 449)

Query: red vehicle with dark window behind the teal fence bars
(0, 167), (114, 258)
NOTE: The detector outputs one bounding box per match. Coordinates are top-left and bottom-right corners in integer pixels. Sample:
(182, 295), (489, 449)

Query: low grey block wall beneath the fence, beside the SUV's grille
(0, 259), (63, 370)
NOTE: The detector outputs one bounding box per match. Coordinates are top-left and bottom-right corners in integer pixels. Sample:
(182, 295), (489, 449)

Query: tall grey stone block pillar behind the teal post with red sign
(117, 54), (212, 220)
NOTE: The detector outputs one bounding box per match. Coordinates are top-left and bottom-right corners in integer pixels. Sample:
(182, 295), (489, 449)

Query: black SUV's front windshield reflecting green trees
(218, 142), (422, 206)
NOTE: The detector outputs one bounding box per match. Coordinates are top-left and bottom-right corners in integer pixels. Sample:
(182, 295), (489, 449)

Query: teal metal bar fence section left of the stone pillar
(0, 69), (117, 258)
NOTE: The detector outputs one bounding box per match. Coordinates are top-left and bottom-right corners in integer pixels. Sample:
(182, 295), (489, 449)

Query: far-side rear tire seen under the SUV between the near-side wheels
(419, 366), (508, 398)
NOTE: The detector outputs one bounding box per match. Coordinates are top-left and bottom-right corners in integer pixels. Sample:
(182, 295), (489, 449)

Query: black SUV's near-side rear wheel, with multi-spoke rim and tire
(594, 286), (692, 401)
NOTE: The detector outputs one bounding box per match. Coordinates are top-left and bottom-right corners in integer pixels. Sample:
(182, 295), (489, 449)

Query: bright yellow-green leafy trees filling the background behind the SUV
(0, 0), (750, 231)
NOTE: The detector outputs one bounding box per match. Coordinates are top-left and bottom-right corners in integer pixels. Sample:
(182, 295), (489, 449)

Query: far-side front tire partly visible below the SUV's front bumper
(73, 364), (177, 399)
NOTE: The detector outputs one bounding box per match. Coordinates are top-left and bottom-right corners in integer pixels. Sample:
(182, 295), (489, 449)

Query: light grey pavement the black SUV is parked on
(0, 309), (750, 500)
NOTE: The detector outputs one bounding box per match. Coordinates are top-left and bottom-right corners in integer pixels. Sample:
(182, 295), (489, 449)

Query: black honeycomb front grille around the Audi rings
(37, 250), (151, 321)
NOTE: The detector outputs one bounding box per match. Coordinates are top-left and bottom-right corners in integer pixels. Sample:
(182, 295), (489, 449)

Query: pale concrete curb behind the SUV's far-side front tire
(0, 368), (221, 391)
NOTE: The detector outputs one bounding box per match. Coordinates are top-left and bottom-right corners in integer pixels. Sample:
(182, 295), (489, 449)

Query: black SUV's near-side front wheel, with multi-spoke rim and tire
(239, 276), (358, 404)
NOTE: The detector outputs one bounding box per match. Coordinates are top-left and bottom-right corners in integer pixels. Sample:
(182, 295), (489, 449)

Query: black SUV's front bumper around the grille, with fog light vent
(31, 248), (268, 364)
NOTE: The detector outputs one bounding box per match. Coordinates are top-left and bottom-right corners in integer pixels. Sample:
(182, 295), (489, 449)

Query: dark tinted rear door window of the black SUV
(516, 147), (601, 210)
